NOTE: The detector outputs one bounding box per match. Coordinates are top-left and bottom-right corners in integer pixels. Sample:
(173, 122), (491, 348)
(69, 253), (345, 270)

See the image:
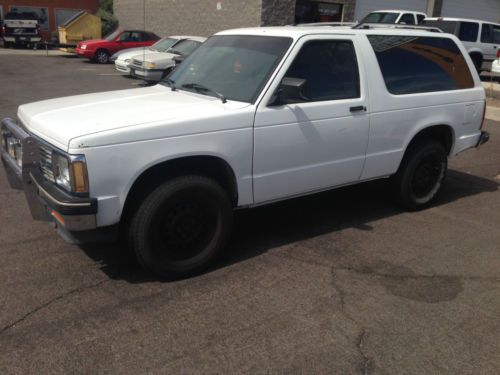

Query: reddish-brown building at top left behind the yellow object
(0, 0), (99, 40)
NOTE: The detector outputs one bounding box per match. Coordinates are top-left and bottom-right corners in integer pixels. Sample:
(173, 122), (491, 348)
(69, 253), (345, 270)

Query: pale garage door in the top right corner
(441, 0), (500, 22)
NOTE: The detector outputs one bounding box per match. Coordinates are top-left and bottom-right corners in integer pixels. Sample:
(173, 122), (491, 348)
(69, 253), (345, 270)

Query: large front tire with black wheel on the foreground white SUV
(129, 176), (233, 279)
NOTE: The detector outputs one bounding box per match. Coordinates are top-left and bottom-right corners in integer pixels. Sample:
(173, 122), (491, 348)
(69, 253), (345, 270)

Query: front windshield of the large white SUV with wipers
(165, 35), (292, 103)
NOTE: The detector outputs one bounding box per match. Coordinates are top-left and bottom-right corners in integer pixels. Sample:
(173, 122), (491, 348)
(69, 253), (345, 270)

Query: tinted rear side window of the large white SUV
(368, 35), (474, 95)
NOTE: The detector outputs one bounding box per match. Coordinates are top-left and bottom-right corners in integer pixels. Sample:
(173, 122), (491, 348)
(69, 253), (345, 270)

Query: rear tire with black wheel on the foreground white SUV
(392, 138), (448, 211)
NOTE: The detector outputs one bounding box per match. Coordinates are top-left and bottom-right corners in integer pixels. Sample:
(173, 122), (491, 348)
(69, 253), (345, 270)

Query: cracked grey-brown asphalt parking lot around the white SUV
(0, 49), (500, 374)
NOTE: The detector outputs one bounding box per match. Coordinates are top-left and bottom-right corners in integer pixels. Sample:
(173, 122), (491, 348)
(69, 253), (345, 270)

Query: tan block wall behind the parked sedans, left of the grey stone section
(113, 0), (261, 36)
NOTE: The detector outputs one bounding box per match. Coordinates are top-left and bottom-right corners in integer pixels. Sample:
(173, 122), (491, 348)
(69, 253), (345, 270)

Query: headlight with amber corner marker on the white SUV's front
(52, 152), (89, 193)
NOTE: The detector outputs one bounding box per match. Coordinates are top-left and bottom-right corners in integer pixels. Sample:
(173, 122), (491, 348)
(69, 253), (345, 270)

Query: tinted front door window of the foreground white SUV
(286, 40), (360, 101)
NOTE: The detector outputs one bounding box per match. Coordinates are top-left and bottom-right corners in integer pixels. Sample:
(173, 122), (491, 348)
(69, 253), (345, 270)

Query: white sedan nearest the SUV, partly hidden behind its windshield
(129, 37), (206, 82)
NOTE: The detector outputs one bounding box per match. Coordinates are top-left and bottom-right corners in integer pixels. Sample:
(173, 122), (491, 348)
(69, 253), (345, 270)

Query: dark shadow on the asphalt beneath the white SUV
(81, 170), (498, 283)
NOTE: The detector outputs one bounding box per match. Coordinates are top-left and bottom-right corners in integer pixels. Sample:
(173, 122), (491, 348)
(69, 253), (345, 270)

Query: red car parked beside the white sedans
(76, 30), (160, 64)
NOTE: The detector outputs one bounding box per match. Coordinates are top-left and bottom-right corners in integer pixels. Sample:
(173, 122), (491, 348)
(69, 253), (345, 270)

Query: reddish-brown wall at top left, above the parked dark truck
(0, 0), (99, 40)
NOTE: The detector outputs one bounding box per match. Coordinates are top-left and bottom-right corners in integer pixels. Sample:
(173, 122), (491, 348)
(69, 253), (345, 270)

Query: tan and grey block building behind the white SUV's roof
(114, 0), (500, 36)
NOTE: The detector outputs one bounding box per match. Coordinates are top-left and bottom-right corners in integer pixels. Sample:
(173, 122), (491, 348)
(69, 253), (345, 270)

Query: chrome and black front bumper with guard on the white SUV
(0, 118), (97, 231)
